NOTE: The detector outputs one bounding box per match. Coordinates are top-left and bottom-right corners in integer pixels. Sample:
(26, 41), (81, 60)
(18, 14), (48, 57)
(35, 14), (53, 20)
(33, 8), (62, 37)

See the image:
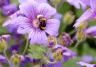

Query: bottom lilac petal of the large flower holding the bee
(29, 30), (47, 45)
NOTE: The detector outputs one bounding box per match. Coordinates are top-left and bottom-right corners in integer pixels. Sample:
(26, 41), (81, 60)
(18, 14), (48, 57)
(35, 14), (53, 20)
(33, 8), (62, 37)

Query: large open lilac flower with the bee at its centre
(4, 1), (60, 44)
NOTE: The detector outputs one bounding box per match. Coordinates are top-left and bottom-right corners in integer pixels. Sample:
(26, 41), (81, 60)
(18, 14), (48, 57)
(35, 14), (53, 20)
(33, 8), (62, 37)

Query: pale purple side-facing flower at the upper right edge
(74, 0), (96, 28)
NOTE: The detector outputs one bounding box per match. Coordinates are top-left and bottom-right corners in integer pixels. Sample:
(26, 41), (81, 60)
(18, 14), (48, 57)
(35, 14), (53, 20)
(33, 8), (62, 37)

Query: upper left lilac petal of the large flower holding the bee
(20, 2), (38, 20)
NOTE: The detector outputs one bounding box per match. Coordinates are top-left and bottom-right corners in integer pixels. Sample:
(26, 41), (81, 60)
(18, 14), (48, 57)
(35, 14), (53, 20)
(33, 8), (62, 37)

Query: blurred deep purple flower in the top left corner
(0, 0), (18, 16)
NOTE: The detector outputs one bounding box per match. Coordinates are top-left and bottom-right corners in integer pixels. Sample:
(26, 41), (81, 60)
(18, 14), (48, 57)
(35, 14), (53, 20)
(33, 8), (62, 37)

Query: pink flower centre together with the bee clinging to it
(33, 15), (47, 30)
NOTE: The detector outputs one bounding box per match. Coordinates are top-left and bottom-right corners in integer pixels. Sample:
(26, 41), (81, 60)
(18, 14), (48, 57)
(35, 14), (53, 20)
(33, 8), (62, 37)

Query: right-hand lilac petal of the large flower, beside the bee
(45, 19), (60, 36)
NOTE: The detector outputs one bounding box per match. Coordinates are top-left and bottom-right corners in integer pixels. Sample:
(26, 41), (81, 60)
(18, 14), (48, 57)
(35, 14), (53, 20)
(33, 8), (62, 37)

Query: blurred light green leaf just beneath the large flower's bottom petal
(28, 45), (47, 59)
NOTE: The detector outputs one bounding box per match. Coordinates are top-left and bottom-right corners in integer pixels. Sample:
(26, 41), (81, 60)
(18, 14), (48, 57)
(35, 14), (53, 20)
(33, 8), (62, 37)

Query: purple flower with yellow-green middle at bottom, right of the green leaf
(42, 45), (76, 67)
